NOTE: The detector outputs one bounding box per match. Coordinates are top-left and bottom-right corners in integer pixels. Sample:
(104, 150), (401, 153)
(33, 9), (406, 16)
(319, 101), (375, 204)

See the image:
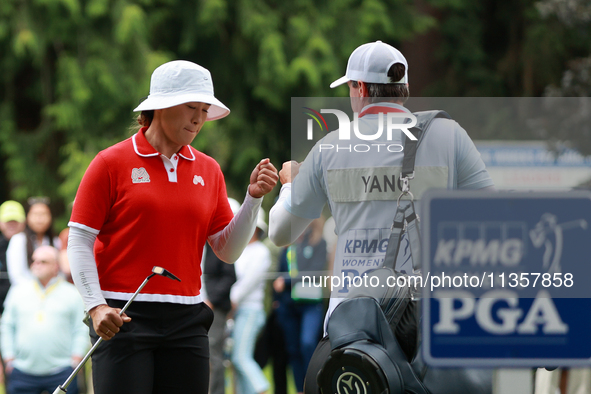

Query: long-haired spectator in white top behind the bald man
(6, 197), (61, 285)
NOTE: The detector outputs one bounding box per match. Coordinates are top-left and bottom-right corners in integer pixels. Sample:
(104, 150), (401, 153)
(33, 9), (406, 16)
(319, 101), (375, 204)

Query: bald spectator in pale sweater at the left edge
(0, 245), (88, 394)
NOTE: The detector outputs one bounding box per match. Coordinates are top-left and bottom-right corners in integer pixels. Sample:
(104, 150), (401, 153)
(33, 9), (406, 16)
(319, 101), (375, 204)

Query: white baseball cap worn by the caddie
(330, 41), (408, 88)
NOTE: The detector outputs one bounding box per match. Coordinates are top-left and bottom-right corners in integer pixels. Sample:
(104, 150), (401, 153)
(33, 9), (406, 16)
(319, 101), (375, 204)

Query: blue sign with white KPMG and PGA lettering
(421, 190), (591, 367)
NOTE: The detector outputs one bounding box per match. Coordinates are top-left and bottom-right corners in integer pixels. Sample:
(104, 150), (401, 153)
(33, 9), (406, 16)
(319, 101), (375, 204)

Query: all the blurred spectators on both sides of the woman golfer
(0, 197), (336, 394)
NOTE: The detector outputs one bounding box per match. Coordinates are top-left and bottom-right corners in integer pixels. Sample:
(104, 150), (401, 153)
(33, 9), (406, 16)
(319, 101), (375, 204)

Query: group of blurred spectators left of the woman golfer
(0, 197), (90, 394)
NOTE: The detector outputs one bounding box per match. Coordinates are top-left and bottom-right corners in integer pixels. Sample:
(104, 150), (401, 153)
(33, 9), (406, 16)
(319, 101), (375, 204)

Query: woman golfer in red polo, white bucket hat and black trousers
(68, 61), (278, 394)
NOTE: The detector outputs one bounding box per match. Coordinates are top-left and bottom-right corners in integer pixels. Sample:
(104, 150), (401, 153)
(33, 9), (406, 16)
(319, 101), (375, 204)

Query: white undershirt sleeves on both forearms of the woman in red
(68, 192), (263, 312)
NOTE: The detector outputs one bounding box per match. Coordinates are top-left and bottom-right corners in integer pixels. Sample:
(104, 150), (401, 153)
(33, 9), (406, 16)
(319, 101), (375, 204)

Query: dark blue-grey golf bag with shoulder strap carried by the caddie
(317, 111), (492, 394)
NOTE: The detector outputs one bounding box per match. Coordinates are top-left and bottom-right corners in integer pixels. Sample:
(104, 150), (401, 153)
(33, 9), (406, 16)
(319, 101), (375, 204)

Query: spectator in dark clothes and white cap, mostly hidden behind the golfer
(201, 198), (240, 394)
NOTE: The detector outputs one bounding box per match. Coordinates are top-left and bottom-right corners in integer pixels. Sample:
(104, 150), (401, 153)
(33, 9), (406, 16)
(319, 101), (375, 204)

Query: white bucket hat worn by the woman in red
(134, 60), (230, 120)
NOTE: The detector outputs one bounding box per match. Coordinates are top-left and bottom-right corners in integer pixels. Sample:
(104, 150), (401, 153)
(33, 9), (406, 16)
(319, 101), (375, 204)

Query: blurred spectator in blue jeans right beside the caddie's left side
(273, 218), (327, 393)
